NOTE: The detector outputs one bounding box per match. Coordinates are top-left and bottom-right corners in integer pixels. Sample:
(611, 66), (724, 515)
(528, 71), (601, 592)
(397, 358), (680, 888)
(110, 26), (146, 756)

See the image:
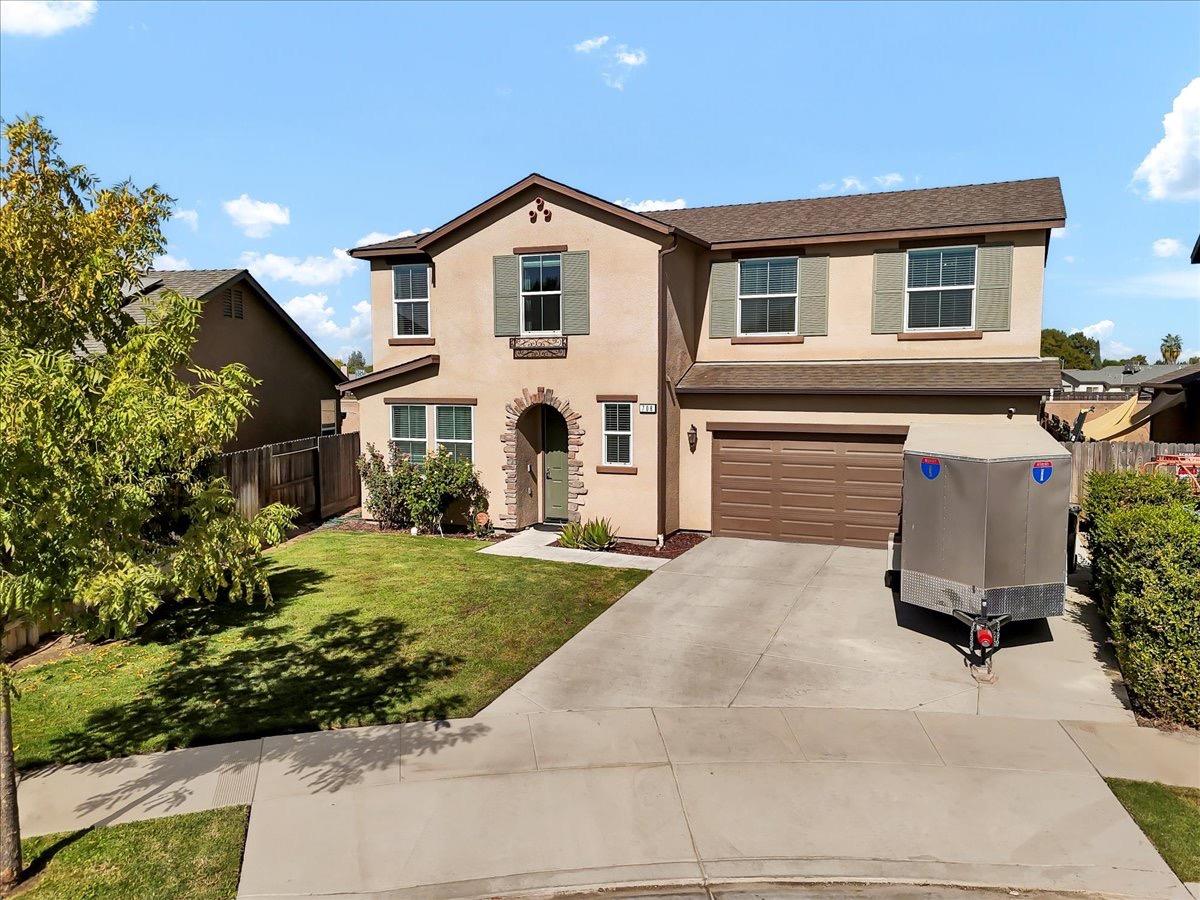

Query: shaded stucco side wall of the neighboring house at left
(192, 278), (338, 450)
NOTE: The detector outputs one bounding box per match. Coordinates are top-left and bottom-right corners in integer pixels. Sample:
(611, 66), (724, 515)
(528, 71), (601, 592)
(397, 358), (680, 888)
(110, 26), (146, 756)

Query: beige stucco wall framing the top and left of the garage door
(679, 395), (1040, 532)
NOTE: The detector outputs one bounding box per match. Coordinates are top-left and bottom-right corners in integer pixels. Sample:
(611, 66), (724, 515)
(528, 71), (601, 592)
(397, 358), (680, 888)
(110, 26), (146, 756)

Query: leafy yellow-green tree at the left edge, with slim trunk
(0, 118), (294, 893)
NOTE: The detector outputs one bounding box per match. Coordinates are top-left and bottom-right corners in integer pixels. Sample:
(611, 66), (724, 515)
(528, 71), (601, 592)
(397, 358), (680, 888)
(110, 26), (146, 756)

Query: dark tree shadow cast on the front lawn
(46, 569), (464, 762)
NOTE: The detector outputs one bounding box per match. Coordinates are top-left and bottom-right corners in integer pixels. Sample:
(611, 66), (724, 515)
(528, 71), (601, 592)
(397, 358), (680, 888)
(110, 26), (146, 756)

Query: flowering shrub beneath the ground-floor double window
(359, 444), (490, 534)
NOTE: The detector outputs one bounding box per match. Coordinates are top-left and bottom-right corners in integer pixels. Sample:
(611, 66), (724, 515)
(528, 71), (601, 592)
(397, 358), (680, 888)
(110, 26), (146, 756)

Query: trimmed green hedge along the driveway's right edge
(1084, 472), (1200, 726)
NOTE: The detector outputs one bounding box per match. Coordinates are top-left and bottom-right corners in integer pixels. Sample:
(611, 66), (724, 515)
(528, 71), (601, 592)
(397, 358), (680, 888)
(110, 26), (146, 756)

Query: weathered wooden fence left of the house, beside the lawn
(217, 432), (361, 521)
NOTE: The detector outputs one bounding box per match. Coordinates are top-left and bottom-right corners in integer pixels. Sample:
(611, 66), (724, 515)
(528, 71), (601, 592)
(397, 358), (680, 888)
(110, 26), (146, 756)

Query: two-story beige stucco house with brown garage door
(344, 174), (1066, 546)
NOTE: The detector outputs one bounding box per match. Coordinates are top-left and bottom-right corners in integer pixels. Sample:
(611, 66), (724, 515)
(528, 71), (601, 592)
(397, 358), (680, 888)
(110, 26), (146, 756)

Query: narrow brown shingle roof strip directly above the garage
(677, 359), (1061, 395)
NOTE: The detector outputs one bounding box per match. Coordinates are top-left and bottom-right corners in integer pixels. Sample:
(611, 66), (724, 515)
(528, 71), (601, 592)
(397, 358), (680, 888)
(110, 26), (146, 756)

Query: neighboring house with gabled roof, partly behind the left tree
(90, 269), (346, 450)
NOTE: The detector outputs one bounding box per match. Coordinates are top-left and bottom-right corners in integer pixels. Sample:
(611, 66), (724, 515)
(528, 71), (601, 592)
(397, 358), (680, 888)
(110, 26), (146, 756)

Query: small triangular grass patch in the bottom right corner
(1108, 778), (1200, 881)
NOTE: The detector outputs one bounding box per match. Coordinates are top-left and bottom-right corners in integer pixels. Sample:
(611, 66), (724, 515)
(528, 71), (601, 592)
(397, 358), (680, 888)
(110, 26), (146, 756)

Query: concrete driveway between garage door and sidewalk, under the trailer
(485, 538), (1134, 724)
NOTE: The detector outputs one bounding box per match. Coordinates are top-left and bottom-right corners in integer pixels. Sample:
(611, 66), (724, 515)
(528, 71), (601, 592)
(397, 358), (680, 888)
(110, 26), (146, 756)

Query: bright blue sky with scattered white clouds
(0, 0), (1200, 360)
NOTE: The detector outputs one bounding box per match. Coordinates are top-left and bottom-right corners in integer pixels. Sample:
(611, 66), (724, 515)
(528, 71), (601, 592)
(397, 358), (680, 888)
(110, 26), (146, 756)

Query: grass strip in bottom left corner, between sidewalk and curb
(17, 806), (250, 900)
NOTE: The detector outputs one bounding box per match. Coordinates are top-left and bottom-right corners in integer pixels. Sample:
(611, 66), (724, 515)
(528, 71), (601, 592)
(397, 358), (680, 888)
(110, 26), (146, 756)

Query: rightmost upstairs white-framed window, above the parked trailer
(905, 247), (976, 331)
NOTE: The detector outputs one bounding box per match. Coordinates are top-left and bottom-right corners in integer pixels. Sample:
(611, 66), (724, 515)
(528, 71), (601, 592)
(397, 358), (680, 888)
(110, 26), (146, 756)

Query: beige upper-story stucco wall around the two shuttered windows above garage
(696, 232), (1045, 361)
